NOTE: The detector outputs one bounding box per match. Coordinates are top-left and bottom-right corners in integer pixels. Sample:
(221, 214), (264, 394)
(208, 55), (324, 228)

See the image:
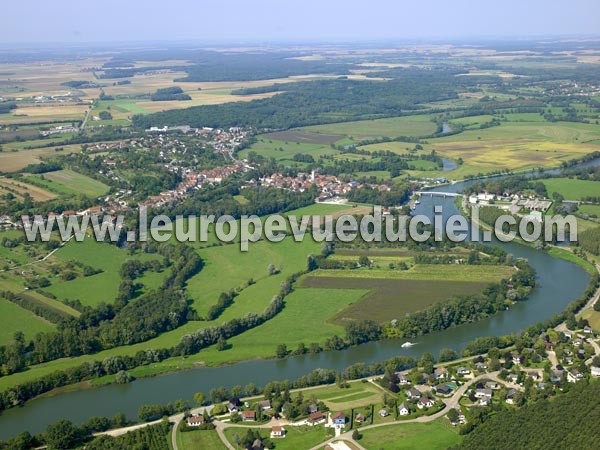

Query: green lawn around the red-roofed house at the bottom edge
(225, 425), (330, 450)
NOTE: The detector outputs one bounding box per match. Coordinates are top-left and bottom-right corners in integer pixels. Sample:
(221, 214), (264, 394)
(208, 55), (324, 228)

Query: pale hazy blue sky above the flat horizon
(0, 0), (600, 44)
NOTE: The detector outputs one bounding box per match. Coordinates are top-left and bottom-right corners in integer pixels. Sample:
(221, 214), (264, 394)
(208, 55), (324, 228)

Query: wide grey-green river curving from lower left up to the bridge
(0, 170), (589, 439)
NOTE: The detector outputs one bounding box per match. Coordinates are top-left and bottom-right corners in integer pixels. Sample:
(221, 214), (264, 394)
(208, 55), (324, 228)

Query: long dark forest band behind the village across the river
(133, 74), (458, 129)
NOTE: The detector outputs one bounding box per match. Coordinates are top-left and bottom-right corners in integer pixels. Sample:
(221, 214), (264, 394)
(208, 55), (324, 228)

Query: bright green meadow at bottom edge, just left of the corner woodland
(360, 418), (461, 450)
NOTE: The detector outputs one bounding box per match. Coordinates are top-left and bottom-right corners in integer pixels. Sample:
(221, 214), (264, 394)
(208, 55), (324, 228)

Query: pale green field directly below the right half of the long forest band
(303, 115), (436, 140)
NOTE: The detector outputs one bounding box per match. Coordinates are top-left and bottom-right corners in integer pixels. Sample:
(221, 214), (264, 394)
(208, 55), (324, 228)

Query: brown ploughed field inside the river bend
(302, 276), (488, 323)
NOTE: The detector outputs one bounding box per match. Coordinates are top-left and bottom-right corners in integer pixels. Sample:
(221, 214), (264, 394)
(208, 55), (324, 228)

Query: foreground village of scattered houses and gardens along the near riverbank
(151, 319), (600, 450)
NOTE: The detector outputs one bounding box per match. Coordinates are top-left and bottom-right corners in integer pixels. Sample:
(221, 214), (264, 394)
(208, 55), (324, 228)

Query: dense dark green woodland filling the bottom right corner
(456, 382), (600, 450)
